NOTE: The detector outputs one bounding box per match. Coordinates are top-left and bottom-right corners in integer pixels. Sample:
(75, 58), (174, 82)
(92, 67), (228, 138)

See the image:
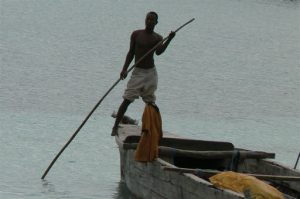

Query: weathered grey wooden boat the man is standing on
(115, 124), (300, 199)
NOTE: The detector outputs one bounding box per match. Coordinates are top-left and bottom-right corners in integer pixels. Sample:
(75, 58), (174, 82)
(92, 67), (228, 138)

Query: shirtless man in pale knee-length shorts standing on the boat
(111, 12), (175, 136)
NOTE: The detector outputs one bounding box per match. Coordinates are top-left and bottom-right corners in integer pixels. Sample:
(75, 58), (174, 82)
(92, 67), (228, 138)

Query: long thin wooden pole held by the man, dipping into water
(41, 18), (195, 179)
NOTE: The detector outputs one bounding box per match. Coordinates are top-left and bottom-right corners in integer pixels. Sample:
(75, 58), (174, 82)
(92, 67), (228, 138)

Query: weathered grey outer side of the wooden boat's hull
(120, 150), (243, 199)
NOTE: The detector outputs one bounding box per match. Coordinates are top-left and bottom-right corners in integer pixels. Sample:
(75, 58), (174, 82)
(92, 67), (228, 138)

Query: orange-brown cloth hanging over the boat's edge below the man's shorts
(135, 104), (162, 162)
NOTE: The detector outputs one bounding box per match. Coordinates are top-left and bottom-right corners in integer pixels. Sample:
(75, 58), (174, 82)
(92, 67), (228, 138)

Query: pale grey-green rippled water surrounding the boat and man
(0, 0), (300, 199)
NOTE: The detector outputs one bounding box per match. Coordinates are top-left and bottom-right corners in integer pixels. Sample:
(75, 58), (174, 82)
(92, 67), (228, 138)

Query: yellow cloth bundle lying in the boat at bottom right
(209, 171), (284, 199)
